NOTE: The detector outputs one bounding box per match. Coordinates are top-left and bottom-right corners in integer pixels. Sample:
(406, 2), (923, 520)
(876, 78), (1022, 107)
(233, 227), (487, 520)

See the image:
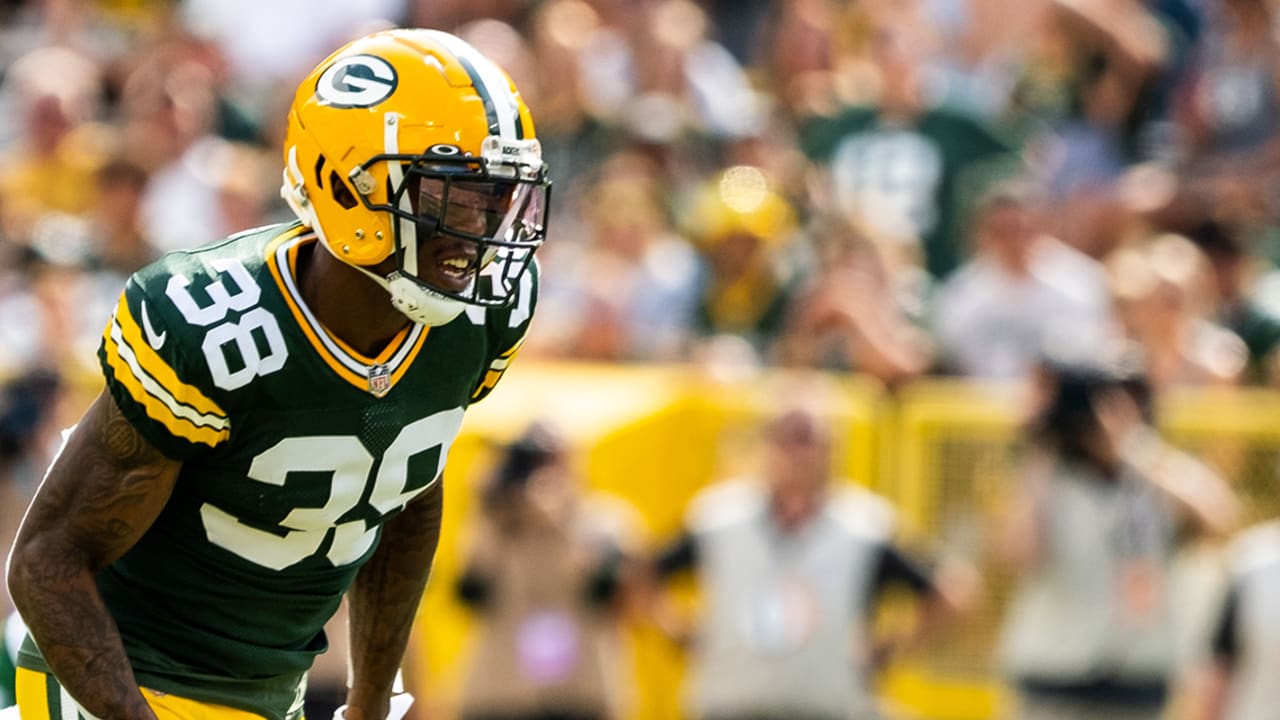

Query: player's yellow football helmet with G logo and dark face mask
(280, 29), (550, 325)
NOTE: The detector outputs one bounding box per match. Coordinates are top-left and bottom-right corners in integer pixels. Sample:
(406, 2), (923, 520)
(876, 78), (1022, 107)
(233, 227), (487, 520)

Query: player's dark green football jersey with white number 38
(20, 224), (538, 720)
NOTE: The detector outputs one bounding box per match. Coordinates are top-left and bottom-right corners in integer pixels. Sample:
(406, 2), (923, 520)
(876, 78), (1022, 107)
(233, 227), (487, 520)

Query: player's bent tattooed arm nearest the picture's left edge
(9, 393), (180, 720)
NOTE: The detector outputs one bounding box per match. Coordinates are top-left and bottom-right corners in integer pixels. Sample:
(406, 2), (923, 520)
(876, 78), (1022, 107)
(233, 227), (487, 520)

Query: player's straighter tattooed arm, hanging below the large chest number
(347, 478), (444, 720)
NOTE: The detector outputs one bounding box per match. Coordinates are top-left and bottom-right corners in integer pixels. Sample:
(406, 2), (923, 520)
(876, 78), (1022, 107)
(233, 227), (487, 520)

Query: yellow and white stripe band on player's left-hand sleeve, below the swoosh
(102, 299), (230, 447)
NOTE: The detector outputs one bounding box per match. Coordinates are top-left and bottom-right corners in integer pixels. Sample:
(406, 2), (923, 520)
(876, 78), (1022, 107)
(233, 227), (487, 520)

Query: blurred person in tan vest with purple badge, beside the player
(458, 424), (645, 720)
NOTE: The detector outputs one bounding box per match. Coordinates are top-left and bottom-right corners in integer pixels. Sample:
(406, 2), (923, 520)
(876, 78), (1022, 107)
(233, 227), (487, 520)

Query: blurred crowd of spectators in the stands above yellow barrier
(0, 0), (1280, 717)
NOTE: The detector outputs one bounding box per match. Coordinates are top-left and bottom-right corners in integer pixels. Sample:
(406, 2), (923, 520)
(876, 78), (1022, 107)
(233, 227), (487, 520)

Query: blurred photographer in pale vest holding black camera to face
(998, 348), (1235, 720)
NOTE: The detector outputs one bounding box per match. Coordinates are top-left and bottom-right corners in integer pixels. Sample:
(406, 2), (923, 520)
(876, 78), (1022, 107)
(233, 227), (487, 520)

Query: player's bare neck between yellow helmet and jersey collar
(298, 242), (410, 357)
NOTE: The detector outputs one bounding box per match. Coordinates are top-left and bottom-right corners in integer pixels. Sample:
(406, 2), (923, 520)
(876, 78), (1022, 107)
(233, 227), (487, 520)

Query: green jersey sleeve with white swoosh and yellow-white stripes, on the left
(99, 275), (230, 460)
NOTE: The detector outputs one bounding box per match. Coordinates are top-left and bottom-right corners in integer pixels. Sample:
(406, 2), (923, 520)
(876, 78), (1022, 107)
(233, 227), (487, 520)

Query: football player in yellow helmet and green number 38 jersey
(8, 29), (549, 720)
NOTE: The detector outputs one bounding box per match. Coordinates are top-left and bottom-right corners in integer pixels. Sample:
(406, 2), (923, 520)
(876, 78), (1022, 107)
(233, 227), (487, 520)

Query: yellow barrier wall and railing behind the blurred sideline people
(47, 363), (1280, 720)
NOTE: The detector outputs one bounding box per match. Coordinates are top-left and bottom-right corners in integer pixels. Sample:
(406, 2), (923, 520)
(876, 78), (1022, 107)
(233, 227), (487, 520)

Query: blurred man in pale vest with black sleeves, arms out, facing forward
(655, 409), (959, 720)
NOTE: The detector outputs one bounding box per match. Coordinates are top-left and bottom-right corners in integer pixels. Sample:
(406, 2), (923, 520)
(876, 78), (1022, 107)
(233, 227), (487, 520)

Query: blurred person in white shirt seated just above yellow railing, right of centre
(932, 183), (1114, 379)
